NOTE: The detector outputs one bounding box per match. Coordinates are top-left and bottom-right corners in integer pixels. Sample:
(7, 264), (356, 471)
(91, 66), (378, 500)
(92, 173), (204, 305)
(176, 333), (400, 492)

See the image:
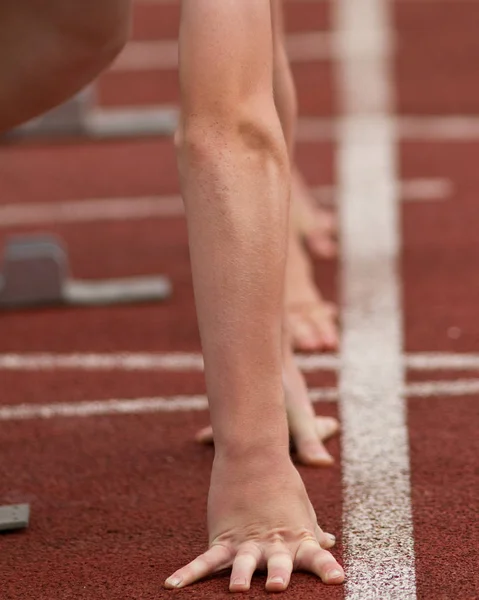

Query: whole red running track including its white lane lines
(0, 0), (479, 600)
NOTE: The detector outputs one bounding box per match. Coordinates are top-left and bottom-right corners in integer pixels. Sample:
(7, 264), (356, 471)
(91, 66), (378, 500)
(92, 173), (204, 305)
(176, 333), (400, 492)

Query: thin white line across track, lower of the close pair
(0, 379), (479, 421)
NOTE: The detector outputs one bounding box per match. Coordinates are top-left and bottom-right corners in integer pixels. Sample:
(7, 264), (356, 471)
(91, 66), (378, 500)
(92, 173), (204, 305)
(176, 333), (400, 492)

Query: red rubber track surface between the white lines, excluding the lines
(0, 0), (479, 600)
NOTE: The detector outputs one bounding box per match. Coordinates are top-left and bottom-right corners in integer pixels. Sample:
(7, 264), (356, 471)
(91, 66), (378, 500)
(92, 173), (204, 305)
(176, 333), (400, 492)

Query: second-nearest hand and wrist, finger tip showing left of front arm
(196, 349), (339, 467)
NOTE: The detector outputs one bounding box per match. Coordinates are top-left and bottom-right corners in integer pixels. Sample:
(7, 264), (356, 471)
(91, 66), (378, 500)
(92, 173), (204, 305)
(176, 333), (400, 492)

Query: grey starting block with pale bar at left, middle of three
(0, 235), (172, 309)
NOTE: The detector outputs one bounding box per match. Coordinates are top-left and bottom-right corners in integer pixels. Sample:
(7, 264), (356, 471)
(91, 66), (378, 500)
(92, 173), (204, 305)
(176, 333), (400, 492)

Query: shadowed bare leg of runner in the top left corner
(0, 0), (130, 132)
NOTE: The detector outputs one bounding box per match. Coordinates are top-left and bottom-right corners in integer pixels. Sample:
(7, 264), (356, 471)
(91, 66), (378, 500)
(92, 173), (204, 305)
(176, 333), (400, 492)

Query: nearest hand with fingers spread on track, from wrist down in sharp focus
(165, 457), (344, 592)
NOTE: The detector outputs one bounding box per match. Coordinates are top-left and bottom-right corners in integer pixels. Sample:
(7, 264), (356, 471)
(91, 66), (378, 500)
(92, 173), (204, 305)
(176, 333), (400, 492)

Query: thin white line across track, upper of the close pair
(0, 352), (479, 373)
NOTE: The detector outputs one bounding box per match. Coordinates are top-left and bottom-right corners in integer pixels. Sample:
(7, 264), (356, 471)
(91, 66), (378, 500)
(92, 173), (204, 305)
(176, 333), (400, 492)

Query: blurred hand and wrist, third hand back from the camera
(285, 219), (339, 352)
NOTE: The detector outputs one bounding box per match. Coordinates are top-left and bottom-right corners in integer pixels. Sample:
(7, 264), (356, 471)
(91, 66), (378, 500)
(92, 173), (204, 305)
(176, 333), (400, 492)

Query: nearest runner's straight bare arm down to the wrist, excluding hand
(178, 0), (289, 453)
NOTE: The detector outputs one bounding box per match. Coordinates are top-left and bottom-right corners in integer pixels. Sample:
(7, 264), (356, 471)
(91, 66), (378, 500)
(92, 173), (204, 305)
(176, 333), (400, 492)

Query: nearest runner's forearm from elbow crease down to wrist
(180, 113), (289, 458)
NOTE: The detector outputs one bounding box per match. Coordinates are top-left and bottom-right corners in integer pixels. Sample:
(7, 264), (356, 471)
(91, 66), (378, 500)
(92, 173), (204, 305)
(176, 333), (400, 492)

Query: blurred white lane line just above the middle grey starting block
(0, 179), (454, 229)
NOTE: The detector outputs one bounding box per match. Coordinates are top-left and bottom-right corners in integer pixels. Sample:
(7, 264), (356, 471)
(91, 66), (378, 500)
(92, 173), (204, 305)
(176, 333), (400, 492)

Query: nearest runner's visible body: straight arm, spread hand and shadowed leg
(0, 0), (344, 591)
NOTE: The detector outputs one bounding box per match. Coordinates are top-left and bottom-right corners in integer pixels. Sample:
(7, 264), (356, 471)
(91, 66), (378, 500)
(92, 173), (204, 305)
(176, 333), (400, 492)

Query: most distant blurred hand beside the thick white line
(291, 168), (337, 258)
